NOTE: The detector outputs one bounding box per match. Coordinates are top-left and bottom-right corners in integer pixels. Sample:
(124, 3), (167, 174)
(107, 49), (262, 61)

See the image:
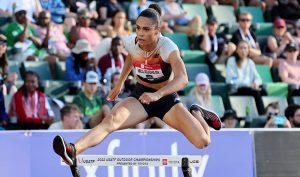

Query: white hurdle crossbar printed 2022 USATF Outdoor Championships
(61, 155), (201, 177)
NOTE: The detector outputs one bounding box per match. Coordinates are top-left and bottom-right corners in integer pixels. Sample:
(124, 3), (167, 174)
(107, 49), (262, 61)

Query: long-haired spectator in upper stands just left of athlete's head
(97, 10), (131, 37)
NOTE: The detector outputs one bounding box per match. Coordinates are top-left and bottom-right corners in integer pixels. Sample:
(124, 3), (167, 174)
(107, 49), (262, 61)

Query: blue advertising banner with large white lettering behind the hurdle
(0, 130), (255, 177)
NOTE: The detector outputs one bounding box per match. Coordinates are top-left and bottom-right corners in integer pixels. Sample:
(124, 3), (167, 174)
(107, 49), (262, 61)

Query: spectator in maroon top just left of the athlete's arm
(98, 37), (126, 81)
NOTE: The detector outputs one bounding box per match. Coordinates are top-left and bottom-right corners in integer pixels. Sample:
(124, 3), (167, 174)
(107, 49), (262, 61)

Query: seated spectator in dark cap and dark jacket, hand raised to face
(199, 16), (235, 64)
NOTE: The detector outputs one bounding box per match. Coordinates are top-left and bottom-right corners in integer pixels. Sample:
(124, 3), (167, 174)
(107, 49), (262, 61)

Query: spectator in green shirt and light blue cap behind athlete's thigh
(73, 71), (110, 128)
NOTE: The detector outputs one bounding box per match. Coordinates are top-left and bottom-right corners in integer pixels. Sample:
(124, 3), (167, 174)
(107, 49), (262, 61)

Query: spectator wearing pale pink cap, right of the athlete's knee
(186, 73), (213, 110)
